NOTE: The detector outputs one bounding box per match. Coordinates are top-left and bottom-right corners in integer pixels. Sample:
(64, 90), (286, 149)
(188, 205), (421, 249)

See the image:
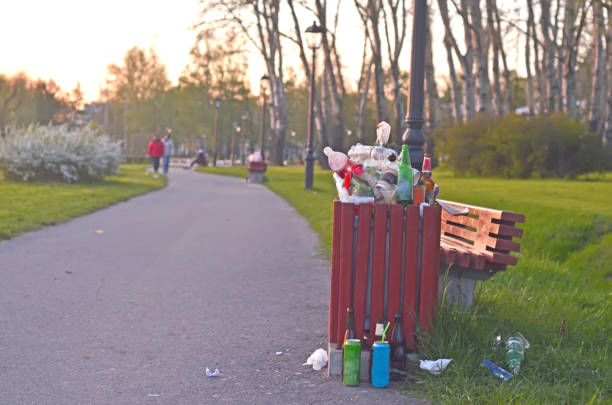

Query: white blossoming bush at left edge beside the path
(0, 125), (121, 183)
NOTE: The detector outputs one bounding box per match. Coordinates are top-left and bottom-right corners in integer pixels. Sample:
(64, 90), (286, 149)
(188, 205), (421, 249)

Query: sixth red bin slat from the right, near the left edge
(336, 203), (355, 343)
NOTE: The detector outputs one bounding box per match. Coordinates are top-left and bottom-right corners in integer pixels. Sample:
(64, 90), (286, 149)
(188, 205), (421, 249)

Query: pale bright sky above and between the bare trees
(0, 0), (524, 100)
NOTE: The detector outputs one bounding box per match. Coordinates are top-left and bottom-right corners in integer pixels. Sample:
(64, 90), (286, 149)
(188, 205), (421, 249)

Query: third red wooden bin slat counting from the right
(387, 204), (404, 330)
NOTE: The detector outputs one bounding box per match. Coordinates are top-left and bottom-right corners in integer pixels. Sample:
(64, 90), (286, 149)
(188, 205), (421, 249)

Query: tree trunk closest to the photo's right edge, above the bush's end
(589, 0), (605, 133)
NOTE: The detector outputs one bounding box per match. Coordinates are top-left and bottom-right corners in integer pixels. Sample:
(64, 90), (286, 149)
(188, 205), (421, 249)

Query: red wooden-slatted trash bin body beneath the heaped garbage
(328, 194), (441, 349)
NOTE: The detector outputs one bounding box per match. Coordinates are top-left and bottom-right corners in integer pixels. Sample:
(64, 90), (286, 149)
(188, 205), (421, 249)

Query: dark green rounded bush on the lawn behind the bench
(434, 114), (605, 178)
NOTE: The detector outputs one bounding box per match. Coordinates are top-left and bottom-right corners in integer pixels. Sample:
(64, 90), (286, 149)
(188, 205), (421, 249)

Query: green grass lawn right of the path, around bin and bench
(201, 167), (612, 404)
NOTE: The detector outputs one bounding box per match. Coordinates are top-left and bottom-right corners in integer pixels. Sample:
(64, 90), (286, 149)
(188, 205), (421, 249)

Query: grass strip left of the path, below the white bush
(0, 164), (166, 240)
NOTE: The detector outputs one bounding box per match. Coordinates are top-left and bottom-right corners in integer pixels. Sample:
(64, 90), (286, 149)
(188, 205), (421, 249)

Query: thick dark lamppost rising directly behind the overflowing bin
(402, 0), (427, 170)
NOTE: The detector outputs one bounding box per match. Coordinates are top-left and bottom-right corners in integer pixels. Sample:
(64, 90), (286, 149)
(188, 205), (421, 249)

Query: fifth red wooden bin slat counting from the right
(353, 204), (372, 339)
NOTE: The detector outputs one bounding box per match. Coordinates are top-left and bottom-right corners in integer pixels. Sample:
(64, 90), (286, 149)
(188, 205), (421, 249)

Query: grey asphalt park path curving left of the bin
(0, 170), (426, 405)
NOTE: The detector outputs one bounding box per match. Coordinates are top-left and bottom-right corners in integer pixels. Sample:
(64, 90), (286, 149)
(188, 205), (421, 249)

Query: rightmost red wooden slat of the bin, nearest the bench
(419, 206), (441, 333)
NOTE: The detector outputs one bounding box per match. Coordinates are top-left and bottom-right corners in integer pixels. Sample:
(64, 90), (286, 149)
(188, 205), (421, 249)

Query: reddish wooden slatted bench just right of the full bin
(440, 200), (525, 306)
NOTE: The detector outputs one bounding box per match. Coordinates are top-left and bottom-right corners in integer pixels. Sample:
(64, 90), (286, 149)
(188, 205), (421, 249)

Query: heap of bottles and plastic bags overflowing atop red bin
(323, 121), (439, 205)
